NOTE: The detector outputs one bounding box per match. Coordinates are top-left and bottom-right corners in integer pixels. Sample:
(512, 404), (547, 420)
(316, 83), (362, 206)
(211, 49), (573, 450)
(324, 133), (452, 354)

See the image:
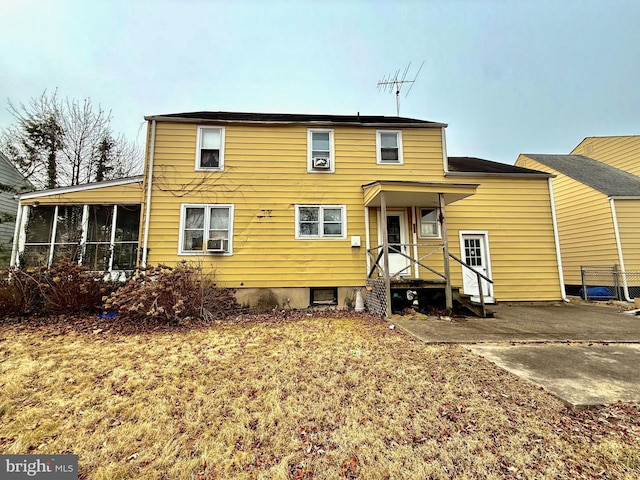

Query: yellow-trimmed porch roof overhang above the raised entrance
(362, 180), (479, 207)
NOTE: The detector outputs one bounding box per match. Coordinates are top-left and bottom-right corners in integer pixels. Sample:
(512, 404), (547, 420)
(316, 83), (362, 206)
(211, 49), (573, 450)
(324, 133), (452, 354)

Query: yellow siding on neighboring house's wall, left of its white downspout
(516, 155), (618, 285)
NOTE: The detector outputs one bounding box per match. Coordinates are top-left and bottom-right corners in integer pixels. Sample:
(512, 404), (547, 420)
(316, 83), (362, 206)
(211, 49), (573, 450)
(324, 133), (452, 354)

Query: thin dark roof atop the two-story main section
(144, 112), (444, 127)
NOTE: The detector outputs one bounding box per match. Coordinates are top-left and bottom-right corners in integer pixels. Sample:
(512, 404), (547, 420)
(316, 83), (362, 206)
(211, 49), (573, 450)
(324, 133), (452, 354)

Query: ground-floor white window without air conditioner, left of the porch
(296, 205), (347, 238)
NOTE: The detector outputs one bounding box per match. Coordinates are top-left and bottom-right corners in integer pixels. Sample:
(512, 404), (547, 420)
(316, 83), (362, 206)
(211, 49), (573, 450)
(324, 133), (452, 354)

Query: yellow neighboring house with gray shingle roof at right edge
(516, 152), (640, 300)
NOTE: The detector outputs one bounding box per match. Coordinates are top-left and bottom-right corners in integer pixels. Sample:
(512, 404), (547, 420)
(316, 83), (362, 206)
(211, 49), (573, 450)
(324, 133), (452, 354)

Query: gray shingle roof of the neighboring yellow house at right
(523, 153), (640, 197)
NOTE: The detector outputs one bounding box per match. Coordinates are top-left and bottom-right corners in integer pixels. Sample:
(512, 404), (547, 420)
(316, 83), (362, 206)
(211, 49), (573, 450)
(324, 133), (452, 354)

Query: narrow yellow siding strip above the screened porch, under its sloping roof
(21, 183), (142, 205)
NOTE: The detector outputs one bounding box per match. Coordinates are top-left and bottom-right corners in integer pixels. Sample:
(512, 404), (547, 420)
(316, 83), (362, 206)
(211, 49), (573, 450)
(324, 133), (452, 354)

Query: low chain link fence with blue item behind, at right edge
(580, 265), (640, 301)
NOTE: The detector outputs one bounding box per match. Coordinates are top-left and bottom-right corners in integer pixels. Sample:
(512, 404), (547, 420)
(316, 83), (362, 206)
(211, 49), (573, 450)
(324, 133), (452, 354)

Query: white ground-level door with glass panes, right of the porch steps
(460, 232), (495, 303)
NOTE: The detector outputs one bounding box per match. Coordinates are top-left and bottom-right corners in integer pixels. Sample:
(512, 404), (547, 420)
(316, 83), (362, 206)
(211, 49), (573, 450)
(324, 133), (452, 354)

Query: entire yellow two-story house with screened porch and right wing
(14, 112), (564, 311)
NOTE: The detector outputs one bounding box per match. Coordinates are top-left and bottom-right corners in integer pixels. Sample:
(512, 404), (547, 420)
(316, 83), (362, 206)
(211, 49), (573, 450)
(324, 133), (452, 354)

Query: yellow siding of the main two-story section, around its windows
(148, 122), (443, 287)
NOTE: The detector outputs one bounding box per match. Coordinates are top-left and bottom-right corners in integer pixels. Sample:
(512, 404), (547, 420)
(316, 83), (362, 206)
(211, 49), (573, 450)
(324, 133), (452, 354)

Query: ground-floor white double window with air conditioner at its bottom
(180, 204), (233, 254)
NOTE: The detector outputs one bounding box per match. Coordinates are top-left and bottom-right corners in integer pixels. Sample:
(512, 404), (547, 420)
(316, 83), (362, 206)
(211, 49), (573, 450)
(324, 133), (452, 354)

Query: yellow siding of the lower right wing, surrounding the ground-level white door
(446, 177), (560, 301)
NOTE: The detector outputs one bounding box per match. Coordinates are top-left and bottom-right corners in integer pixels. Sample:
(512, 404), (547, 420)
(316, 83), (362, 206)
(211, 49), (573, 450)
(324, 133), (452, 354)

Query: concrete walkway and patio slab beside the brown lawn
(392, 303), (640, 407)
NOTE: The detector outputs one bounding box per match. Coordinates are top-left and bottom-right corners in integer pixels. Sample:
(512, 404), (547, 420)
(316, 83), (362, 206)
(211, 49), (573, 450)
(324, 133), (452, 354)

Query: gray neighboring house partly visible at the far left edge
(0, 152), (33, 269)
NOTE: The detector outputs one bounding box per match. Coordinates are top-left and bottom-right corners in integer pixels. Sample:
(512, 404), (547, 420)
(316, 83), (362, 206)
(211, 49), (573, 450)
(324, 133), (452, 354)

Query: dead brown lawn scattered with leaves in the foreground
(0, 317), (640, 480)
